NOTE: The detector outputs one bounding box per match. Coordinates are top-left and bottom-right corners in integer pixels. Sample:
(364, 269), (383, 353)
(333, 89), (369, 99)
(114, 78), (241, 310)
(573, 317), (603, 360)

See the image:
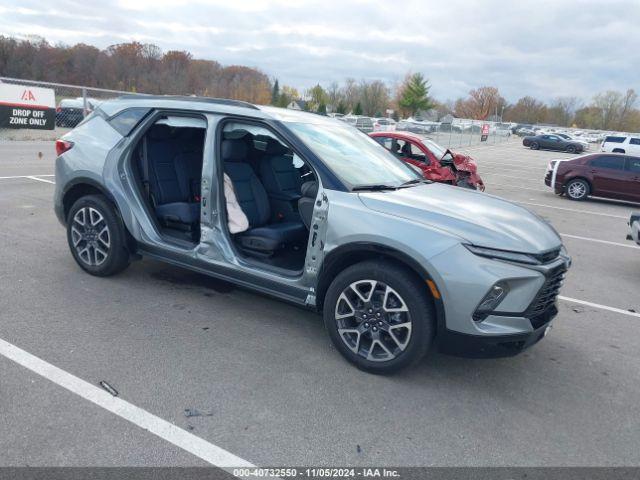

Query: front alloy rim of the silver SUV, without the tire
(334, 280), (411, 362)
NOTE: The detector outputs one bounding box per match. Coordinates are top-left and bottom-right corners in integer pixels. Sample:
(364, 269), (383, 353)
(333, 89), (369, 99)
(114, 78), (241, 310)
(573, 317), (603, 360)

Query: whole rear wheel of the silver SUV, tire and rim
(67, 195), (129, 277)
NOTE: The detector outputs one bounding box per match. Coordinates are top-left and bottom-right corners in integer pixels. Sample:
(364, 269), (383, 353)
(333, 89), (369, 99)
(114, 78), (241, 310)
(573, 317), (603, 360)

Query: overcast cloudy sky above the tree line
(0, 0), (640, 101)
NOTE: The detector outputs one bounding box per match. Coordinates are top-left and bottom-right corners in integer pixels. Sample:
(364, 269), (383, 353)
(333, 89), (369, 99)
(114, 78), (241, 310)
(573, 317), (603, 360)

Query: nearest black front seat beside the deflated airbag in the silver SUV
(222, 140), (307, 254)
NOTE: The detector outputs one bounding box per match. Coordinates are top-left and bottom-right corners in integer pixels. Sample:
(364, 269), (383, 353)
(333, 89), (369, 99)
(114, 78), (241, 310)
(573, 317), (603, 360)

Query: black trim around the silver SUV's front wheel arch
(316, 242), (445, 334)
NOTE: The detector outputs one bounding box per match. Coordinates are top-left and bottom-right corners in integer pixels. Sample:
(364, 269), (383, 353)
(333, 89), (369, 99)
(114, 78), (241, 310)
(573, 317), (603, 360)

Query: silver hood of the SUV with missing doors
(359, 183), (562, 253)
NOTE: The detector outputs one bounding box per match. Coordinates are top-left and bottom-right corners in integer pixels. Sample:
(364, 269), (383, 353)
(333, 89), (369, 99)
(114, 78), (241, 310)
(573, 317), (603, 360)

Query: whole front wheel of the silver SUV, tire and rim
(323, 261), (435, 374)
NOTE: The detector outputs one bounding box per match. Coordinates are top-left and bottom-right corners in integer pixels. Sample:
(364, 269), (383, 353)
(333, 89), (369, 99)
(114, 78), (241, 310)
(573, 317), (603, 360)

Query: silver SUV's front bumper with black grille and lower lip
(431, 247), (571, 357)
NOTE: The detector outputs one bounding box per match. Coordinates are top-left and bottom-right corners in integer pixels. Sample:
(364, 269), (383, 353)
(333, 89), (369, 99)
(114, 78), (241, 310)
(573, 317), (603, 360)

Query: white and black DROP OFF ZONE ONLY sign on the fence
(0, 83), (56, 130)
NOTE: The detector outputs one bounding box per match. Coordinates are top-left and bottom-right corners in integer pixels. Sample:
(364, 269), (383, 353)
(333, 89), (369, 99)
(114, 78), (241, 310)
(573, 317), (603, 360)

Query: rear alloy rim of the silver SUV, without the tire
(71, 207), (111, 266)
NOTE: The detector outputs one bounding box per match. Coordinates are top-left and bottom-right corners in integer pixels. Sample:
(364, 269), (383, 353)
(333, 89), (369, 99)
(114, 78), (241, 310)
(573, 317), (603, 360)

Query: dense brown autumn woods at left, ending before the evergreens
(0, 36), (271, 104)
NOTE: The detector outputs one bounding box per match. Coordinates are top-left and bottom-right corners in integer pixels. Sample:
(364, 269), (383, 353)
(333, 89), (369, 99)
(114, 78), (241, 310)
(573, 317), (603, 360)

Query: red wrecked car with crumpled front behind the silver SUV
(370, 132), (484, 191)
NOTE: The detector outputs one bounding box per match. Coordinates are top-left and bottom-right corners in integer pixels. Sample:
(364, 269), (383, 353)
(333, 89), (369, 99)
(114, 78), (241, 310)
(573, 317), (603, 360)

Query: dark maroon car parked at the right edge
(544, 153), (640, 202)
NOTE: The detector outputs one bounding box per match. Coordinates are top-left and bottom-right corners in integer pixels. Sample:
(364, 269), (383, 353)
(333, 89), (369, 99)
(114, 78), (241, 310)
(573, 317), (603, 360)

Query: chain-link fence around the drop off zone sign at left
(0, 77), (139, 142)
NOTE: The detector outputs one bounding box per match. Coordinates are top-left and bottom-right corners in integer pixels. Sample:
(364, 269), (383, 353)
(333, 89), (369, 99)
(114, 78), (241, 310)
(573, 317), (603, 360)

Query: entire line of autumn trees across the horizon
(0, 36), (640, 131)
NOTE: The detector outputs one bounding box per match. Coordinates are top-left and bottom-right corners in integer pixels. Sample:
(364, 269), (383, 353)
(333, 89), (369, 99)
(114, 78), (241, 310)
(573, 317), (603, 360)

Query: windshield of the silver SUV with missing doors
(288, 123), (422, 188)
